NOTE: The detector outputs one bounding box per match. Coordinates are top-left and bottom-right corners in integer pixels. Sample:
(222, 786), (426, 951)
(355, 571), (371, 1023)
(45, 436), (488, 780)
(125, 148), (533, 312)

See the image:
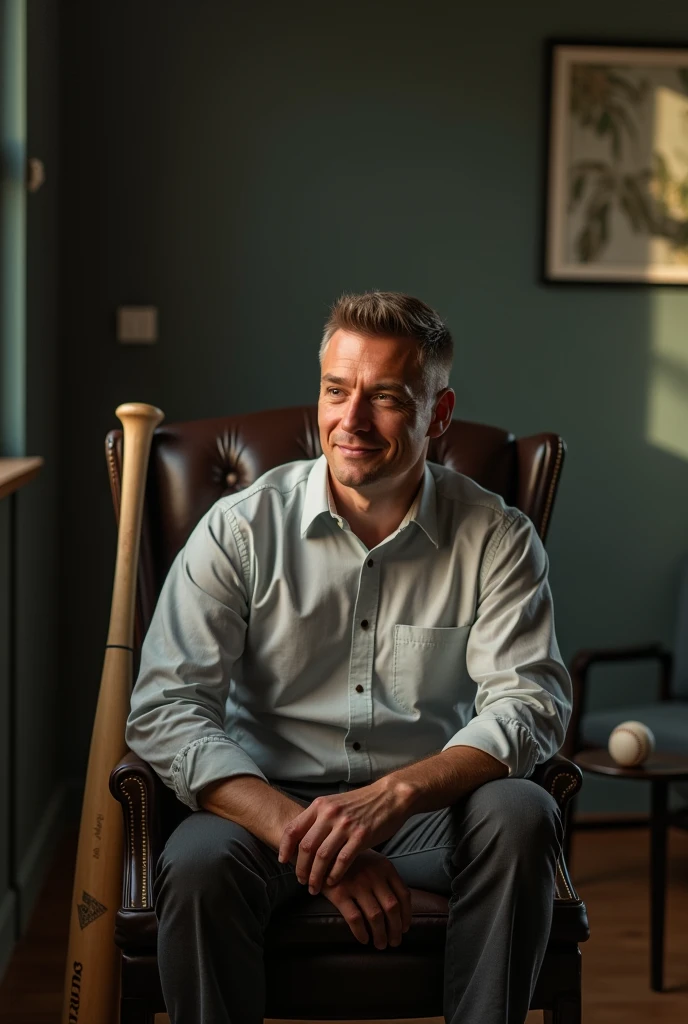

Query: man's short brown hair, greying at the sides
(320, 292), (454, 394)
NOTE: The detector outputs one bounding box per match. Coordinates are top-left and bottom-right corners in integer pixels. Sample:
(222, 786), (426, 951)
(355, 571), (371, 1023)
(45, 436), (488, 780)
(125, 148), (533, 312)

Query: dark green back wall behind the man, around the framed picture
(59, 0), (688, 815)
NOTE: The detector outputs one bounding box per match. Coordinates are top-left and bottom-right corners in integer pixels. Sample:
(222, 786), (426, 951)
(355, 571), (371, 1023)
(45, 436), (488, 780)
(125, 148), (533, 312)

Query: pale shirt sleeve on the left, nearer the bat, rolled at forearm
(126, 503), (267, 810)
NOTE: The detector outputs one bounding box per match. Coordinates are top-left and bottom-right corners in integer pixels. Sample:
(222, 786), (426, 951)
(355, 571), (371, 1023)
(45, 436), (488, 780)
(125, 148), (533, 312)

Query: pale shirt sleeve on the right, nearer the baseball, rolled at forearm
(442, 514), (571, 777)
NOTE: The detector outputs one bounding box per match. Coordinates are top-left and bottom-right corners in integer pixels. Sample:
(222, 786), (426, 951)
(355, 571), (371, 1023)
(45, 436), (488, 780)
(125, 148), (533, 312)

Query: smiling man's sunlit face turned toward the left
(317, 330), (441, 488)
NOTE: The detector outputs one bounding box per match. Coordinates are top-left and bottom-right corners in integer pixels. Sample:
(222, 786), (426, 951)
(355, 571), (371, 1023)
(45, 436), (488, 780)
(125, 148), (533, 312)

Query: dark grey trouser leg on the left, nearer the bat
(155, 811), (301, 1024)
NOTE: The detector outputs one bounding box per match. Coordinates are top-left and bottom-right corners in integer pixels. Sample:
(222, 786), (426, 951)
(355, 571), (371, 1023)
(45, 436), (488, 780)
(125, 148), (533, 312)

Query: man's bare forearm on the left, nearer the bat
(199, 775), (303, 850)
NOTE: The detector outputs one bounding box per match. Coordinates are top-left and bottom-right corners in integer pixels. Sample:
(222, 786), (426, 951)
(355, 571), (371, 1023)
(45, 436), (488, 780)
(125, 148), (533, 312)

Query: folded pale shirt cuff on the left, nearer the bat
(171, 735), (269, 811)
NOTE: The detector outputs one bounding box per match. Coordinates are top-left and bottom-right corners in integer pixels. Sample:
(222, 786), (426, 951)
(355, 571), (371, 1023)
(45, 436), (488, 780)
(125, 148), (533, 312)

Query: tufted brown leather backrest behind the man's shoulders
(105, 406), (565, 647)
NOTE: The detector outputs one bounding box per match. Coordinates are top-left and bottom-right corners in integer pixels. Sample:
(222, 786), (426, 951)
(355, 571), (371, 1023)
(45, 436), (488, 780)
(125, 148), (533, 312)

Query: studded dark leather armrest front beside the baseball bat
(110, 751), (165, 910)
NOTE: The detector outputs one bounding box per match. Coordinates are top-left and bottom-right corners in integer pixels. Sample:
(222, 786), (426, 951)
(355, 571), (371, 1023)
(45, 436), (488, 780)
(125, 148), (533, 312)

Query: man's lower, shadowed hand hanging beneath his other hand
(323, 850), (411, 949)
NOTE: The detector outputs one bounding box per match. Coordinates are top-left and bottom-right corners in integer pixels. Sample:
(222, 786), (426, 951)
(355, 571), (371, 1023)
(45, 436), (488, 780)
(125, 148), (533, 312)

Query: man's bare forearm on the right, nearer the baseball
(381, 746), (509, 816)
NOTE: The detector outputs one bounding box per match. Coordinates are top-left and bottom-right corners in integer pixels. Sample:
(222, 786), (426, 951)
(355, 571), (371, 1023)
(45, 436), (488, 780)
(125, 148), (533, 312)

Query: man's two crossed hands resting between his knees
(277, 778), (413, 948)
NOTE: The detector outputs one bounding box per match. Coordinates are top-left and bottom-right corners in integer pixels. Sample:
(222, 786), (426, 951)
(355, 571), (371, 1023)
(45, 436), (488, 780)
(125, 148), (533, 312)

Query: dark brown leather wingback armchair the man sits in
(105, 407), (588, 1024)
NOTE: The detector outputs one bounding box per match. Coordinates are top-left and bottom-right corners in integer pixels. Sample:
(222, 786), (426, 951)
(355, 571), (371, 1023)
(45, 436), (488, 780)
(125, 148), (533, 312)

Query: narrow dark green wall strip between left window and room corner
(14, 0), (62, 928)
